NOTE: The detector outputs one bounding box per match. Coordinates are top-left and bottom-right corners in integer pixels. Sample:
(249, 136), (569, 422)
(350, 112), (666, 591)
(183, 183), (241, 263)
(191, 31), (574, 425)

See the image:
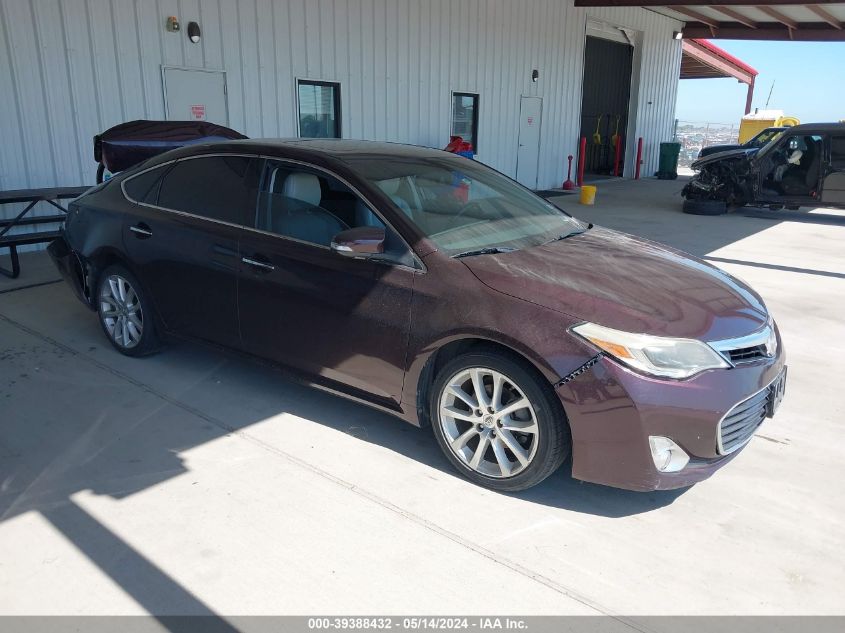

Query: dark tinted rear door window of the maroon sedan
(158, 156), (258, 225)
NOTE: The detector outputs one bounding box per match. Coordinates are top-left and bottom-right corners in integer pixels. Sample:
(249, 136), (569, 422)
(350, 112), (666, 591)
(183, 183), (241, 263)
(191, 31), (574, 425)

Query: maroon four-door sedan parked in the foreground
(50, 140), (786, 490)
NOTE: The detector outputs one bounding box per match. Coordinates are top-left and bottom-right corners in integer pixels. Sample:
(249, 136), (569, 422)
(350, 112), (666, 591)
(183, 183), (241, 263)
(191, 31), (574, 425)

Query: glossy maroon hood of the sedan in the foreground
(461, 227), (768, 341)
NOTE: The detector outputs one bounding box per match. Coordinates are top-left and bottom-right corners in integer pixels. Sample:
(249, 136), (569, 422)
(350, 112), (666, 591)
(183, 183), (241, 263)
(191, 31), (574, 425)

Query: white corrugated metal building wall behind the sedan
(0, 0), (681, 232)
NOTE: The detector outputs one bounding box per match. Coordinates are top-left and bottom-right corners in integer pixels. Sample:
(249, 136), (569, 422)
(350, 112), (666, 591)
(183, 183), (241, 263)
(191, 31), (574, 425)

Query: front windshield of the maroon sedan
(349, 153), (585, 255)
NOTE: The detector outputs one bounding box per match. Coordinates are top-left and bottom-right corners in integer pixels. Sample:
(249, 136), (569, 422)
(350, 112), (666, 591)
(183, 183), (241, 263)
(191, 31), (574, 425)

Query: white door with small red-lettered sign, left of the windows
(164, 68), (229, 126)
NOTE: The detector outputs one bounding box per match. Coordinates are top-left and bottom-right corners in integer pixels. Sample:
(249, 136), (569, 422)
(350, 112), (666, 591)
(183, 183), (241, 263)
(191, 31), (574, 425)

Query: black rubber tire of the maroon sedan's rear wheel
(95, 264), (161, 357)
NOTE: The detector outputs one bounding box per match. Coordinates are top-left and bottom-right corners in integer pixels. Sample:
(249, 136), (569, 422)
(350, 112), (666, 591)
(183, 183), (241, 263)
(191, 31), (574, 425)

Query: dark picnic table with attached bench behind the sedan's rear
(0, 187), (88, 279)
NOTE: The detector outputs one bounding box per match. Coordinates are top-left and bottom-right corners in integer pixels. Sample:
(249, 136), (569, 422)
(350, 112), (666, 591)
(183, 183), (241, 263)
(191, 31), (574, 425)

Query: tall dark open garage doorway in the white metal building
(581, 27), (634, 176)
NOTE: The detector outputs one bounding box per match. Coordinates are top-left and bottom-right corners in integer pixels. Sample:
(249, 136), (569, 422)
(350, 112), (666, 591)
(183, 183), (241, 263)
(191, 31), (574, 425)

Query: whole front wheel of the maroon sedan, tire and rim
(430, 351), (570, 491)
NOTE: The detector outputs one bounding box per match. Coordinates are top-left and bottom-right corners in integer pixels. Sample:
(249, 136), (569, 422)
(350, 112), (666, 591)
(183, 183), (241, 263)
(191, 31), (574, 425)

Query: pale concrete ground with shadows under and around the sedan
(0, 180), (845, 616)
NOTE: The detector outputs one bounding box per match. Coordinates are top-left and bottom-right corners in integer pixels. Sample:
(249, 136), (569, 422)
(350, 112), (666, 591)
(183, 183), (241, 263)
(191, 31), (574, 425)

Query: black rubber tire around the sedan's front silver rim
(429, 349), (571, 492)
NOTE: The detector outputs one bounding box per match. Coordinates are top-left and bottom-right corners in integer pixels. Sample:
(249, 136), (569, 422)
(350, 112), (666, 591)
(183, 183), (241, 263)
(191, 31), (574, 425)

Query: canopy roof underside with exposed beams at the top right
(575, 0), (845, 42)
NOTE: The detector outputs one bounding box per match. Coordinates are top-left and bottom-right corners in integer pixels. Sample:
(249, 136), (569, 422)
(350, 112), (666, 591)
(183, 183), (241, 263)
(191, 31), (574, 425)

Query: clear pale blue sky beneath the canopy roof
(676, 40), (845, 125)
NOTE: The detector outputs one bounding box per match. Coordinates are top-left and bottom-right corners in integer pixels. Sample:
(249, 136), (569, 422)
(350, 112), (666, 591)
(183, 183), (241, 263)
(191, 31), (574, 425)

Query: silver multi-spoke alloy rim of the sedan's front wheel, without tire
(439, 367), (540, 478)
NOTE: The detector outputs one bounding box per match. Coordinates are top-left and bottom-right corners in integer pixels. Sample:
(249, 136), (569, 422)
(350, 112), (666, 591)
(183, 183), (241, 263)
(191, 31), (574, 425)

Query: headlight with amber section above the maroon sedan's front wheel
(572, 323), (730, 378)
